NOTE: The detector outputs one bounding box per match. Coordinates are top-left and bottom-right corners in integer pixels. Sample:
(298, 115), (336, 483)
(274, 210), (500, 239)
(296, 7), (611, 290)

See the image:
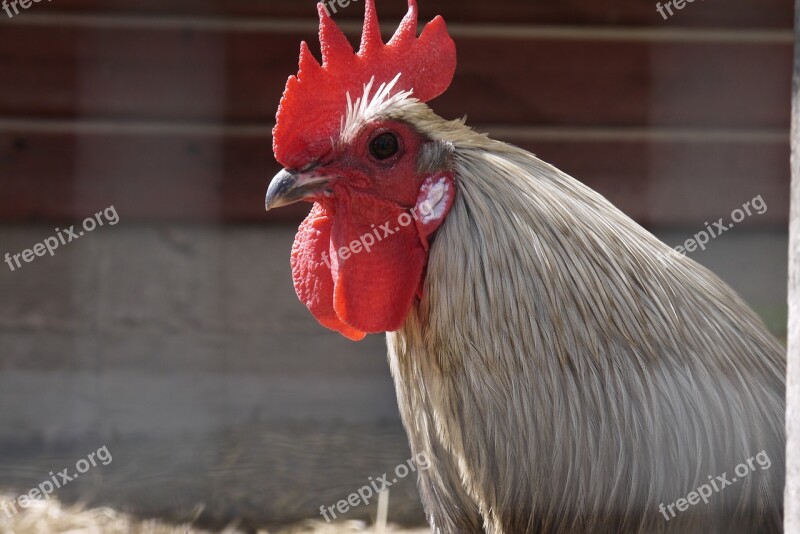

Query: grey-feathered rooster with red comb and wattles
(266, 0), (785, 534)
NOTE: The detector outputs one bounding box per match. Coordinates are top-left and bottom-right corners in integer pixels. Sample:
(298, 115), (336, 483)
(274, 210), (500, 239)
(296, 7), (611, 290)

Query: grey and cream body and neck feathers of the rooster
(382, 100), (785, 534)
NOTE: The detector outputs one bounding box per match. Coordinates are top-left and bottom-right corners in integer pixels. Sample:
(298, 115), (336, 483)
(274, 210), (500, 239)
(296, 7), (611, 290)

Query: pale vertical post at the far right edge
(784, 0), (800, 534)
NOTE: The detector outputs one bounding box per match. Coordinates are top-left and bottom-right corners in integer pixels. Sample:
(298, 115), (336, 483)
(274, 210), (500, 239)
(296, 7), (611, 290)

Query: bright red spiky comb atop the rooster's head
(272, 0), (456, 168)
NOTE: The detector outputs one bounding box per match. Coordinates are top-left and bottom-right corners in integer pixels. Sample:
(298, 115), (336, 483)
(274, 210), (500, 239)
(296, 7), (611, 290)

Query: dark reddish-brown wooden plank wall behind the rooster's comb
(0, 0), (792, 227)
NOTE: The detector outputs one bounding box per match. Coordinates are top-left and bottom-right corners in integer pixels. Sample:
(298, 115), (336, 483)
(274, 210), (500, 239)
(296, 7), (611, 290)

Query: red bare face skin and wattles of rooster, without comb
(292, 122), (455, 340)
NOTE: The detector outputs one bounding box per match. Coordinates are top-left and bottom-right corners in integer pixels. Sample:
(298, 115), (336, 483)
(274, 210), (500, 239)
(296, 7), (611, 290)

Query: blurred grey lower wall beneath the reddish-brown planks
(0, 224), (786, 524)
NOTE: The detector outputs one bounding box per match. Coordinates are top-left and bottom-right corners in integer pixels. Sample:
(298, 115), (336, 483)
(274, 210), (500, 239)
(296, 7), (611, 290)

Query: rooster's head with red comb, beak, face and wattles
(266, 0), (456, 340)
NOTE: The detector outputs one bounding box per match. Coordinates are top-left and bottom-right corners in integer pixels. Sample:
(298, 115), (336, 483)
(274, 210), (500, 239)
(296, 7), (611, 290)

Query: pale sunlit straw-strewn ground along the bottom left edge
(0, 496), (430, 534)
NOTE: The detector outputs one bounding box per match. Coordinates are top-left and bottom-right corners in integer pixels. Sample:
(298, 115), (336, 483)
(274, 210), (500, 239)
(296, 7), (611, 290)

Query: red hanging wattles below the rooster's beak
(292, 188), (427, 340)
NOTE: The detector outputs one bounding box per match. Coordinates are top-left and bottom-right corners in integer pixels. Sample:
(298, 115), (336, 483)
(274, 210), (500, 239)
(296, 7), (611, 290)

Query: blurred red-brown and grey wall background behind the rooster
(0, 0), (793, 528)
